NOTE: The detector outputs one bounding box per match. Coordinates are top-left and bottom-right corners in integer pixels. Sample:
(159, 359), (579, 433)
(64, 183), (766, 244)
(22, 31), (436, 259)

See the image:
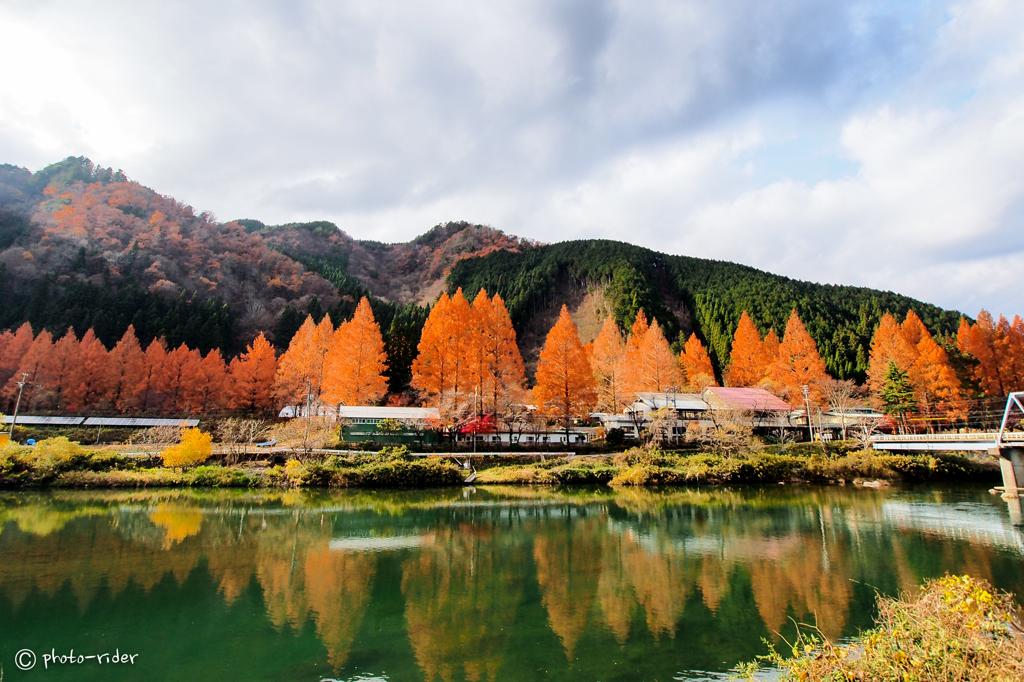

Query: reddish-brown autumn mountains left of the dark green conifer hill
(0, 158), (530, 392)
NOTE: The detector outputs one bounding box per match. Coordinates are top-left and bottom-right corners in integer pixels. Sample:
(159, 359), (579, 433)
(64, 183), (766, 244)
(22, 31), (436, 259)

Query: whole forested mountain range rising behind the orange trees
(0, 158), (959, 392)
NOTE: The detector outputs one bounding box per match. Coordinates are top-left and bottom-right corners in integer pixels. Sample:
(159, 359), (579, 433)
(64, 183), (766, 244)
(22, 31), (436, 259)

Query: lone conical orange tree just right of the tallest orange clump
(534, 305), (597, 443)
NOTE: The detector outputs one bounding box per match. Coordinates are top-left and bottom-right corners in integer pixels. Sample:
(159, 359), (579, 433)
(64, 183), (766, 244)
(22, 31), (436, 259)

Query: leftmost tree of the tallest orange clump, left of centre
(412, 289), (472, 420)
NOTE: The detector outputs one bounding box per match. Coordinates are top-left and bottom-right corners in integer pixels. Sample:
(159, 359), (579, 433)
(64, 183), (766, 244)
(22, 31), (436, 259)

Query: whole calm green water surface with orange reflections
(0, 487), (1024, 682)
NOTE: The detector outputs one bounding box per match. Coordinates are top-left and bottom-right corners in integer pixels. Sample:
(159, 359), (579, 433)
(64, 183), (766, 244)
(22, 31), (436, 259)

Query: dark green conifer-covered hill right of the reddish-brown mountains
(447, 240), (961, 380)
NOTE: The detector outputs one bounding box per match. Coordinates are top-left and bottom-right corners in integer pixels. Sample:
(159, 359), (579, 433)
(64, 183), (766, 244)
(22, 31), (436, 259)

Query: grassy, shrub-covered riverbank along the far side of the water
(0, 438), (998, 488)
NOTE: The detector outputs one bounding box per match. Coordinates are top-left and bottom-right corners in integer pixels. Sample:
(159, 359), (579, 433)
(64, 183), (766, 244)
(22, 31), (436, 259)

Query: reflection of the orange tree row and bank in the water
(0, 488), (1024, 682)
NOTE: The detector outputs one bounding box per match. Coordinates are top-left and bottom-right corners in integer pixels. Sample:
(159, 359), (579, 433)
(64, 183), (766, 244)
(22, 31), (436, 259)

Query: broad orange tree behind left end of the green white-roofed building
(323, 297), (387, 404)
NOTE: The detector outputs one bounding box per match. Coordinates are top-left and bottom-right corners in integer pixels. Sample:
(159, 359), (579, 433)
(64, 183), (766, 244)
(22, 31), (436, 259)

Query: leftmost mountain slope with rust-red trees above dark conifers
(0, 159), (336, 354)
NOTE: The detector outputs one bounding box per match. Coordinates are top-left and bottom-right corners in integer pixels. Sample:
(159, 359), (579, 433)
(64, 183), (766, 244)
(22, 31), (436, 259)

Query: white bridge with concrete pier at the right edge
(871, 391), (1024, 524)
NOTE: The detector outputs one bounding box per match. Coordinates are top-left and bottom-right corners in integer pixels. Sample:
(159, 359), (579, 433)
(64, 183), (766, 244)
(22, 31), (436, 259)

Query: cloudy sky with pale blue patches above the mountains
(0, 0), (1024, 315)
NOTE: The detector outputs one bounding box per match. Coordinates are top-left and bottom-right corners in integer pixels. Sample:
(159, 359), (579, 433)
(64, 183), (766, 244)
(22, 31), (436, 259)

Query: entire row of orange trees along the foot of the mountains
(0, 290), (1024, 426)
